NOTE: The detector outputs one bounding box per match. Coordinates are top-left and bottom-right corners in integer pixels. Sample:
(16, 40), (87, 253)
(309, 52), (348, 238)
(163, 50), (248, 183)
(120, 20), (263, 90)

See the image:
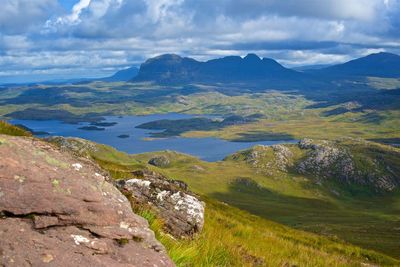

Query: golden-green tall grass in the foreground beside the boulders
(138, 198), (400, 266)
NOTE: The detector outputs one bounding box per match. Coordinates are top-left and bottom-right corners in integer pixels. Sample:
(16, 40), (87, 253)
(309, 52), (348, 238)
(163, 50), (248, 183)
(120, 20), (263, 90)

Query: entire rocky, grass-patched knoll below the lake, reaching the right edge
(226, 138), (400, 192)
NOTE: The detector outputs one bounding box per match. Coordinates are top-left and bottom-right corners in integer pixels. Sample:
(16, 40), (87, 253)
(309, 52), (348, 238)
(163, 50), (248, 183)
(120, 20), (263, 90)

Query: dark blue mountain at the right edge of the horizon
(311, 52), (400, 78)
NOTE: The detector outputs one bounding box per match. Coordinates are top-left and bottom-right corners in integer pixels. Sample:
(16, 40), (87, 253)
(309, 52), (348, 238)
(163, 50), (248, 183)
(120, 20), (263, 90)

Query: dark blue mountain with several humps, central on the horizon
(133, 54), (303, 84)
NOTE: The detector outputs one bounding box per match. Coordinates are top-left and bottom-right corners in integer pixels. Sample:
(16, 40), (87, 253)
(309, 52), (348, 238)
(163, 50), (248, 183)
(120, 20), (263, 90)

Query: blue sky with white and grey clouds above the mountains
(0, 0), (400, 83)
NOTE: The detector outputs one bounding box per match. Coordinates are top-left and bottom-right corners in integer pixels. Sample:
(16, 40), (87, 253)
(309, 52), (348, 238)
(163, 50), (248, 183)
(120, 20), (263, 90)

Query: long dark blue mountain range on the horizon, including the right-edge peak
(127, 52), (400, 84)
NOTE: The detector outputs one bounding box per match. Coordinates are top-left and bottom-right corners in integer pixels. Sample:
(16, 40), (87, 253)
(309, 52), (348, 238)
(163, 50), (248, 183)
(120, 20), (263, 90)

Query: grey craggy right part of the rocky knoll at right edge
(296, 139), (400, 191)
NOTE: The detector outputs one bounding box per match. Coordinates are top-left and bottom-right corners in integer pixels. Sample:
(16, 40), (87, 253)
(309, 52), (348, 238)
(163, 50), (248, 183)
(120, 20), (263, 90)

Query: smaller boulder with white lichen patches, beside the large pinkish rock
(117, 170), (205, 238)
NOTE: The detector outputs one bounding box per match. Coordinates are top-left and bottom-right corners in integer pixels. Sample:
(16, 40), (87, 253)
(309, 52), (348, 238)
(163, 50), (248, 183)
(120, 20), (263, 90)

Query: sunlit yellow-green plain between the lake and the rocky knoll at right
(183, 109), (400, 141)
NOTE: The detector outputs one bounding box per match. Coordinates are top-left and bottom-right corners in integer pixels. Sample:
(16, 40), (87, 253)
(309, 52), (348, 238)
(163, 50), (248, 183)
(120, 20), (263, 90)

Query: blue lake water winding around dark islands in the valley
(10, 113), (295, 161)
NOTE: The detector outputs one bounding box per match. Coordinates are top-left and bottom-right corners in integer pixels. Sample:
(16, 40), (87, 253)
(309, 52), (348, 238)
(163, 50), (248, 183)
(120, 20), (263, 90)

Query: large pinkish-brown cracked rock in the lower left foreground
(0, 135), (173, 266)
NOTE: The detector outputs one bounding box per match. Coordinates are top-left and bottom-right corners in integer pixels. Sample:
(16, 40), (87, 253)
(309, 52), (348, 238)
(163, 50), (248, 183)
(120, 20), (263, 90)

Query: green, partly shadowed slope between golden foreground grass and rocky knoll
(131, 149), (400, 258)
